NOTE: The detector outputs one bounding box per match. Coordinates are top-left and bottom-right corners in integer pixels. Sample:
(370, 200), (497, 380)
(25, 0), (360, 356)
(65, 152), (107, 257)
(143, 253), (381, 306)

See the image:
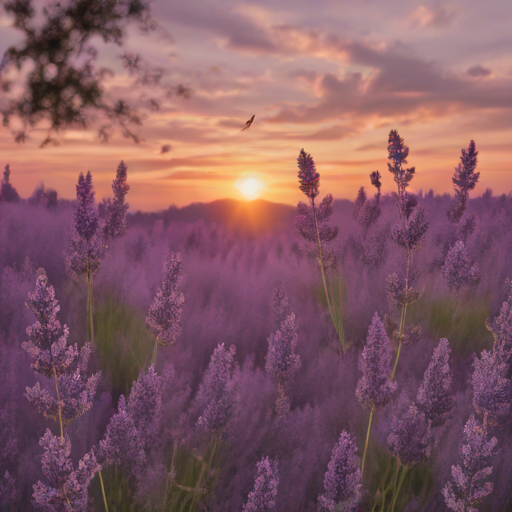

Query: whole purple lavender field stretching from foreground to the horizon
(0, 130), (512, 512)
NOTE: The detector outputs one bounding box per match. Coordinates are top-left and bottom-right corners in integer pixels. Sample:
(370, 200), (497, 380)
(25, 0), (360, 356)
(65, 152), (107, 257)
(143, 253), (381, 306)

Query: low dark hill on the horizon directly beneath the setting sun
(128, 199), (353, 237)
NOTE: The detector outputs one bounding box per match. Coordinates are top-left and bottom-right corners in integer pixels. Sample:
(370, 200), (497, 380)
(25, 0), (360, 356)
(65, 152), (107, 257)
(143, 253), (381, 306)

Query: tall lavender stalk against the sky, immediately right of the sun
(295, 149), (345, 352)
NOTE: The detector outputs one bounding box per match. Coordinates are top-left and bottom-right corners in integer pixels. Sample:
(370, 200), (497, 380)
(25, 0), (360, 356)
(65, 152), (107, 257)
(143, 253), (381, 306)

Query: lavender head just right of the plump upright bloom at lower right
(416, 338), (453, 421)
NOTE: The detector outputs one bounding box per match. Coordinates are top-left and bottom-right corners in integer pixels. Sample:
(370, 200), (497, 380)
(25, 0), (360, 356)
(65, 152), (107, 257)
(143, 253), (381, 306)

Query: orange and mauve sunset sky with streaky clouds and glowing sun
(0, 0), (512, 211)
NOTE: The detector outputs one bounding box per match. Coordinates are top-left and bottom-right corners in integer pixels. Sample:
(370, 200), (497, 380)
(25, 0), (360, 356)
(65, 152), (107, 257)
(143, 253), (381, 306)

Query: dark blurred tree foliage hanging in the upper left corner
(0, 0), (189, 146)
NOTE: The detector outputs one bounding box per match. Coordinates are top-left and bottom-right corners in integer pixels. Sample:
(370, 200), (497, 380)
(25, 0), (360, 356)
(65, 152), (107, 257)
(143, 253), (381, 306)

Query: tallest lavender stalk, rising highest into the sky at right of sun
(388, 130), (428, 380)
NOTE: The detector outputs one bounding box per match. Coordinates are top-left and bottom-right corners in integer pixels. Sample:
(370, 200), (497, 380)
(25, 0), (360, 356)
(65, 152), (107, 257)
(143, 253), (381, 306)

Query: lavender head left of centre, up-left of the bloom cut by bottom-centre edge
(196, 343), (239, 436)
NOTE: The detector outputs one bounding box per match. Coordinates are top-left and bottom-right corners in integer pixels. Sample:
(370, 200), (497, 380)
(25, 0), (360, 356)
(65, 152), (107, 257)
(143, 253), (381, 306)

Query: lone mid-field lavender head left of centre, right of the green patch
(146, 252), (185, 347)
